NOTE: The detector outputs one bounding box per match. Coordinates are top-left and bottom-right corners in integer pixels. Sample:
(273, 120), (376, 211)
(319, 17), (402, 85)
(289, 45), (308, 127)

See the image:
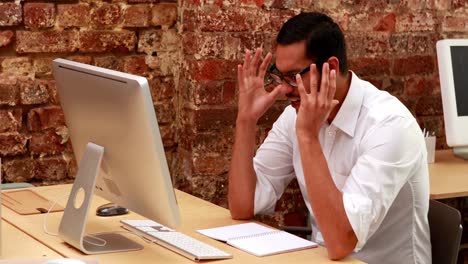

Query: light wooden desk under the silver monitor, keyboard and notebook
(2, 185), (362, 264)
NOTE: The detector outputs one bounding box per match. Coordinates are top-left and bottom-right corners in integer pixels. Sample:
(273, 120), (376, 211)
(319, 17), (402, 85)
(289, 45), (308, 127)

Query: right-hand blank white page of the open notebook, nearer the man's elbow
(227, 231), (317, 257)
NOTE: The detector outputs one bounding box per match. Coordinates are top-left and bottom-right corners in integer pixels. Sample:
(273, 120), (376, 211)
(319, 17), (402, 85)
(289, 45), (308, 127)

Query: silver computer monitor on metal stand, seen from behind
(53, 59), (180, 254)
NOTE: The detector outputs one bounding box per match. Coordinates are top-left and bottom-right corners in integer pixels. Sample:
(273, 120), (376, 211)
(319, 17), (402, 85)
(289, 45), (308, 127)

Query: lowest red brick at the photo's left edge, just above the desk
(2, 158), (34, 182)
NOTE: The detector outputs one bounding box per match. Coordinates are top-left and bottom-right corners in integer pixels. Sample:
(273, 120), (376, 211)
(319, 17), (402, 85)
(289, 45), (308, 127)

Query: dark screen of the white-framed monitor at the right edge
(450, 46), (468, 116)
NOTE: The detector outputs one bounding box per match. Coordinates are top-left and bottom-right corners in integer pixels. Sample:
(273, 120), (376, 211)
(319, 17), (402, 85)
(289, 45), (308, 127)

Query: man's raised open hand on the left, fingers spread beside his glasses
(237, 48), (292, 124)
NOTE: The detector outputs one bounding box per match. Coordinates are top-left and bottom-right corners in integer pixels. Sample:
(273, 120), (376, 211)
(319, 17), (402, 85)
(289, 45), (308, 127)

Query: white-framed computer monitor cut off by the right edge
(436, 39), (468, 159)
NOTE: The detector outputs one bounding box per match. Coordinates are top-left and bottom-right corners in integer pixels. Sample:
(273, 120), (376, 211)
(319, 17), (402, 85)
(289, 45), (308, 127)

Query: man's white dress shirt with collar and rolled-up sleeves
(254, 73), (431, 264)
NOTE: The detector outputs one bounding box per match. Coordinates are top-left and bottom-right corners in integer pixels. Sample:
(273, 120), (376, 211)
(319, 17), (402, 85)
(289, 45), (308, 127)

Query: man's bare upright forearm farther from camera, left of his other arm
(228, 120), (256, 219)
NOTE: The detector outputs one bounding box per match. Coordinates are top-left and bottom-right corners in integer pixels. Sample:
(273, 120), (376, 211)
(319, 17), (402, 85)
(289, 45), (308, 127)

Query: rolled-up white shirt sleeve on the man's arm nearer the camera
(342, 117), (425, 252)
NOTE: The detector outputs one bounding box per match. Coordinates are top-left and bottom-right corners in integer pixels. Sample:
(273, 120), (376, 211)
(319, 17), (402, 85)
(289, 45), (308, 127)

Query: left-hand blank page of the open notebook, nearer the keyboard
(197, 223), (276, 242)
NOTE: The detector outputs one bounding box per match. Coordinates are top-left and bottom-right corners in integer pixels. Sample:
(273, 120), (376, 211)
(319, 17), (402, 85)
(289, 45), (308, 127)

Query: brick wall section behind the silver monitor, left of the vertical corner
(0, 0), (181, 184)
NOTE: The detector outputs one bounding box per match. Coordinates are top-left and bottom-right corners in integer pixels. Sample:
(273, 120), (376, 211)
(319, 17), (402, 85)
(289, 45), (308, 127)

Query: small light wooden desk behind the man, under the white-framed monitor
(429, 150), (468, 199)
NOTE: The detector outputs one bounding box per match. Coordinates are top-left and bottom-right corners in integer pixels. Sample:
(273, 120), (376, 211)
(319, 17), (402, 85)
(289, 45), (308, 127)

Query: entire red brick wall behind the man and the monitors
(0, 0), (468, 227)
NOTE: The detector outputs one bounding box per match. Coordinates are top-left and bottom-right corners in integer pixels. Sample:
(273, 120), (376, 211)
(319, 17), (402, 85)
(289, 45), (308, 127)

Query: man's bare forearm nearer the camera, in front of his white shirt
(299, 139), (357, 259)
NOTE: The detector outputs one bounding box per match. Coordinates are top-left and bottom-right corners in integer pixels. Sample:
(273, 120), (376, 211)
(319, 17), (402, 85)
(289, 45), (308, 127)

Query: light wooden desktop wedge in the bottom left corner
(0, 221), (62, 259)
